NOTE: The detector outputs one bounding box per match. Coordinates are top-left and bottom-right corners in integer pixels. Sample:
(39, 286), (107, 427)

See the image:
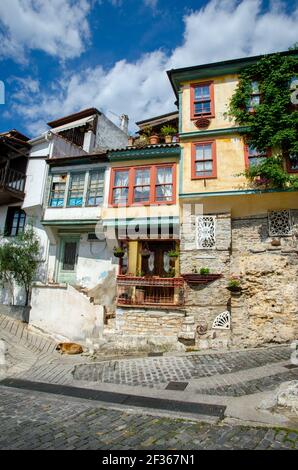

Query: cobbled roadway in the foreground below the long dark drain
(0, 386), (298, 450)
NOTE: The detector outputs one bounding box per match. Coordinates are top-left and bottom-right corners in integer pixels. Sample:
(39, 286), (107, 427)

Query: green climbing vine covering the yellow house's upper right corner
(229, 54), (298, 189)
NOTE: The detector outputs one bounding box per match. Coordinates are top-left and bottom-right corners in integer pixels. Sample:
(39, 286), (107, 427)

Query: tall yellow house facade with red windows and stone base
(168, 52), (298, 348)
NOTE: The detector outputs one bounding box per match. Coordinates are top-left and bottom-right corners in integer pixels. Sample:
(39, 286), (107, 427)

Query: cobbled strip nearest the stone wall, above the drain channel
(74, 346), (294, 394)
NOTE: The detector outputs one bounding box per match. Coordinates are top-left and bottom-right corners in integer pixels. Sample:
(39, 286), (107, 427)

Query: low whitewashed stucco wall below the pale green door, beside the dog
(29, 286), (103, 341)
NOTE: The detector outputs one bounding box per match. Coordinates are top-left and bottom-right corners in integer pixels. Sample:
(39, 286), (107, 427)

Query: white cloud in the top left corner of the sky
(0, 0), (90, 62)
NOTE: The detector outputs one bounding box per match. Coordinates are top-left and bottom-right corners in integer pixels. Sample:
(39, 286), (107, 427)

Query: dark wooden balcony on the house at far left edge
(0, 168), (26, 204)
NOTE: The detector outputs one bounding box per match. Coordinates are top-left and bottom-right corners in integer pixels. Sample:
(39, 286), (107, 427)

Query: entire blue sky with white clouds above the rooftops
(0, 0), (298, 137)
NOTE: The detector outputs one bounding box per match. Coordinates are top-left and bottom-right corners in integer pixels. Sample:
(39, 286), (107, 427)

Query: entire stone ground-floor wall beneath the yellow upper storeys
(180, 211), (298, 348)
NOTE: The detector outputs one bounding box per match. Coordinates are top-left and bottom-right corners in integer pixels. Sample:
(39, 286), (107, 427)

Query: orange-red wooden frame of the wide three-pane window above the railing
(109, 163), (176, 207)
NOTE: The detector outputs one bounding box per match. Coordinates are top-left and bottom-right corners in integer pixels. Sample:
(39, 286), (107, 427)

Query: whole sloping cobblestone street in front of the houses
(0, 315), (298, 450)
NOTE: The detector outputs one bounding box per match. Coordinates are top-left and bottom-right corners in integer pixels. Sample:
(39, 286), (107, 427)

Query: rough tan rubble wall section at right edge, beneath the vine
(231, 211), (298, 346)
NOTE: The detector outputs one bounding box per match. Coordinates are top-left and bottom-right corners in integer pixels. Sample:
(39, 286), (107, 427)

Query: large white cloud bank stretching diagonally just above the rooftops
(10, 0), (298, 136)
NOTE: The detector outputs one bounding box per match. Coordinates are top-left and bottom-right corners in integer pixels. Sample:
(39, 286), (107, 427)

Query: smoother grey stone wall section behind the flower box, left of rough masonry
(180, 214), (232, 348)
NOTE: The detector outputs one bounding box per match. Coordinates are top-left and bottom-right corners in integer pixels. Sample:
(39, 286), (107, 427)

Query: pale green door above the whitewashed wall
(58, 238), (80, 284)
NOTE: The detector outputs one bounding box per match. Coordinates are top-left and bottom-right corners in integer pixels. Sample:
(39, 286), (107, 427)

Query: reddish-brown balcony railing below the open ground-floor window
(117, 275), (184, 306)
